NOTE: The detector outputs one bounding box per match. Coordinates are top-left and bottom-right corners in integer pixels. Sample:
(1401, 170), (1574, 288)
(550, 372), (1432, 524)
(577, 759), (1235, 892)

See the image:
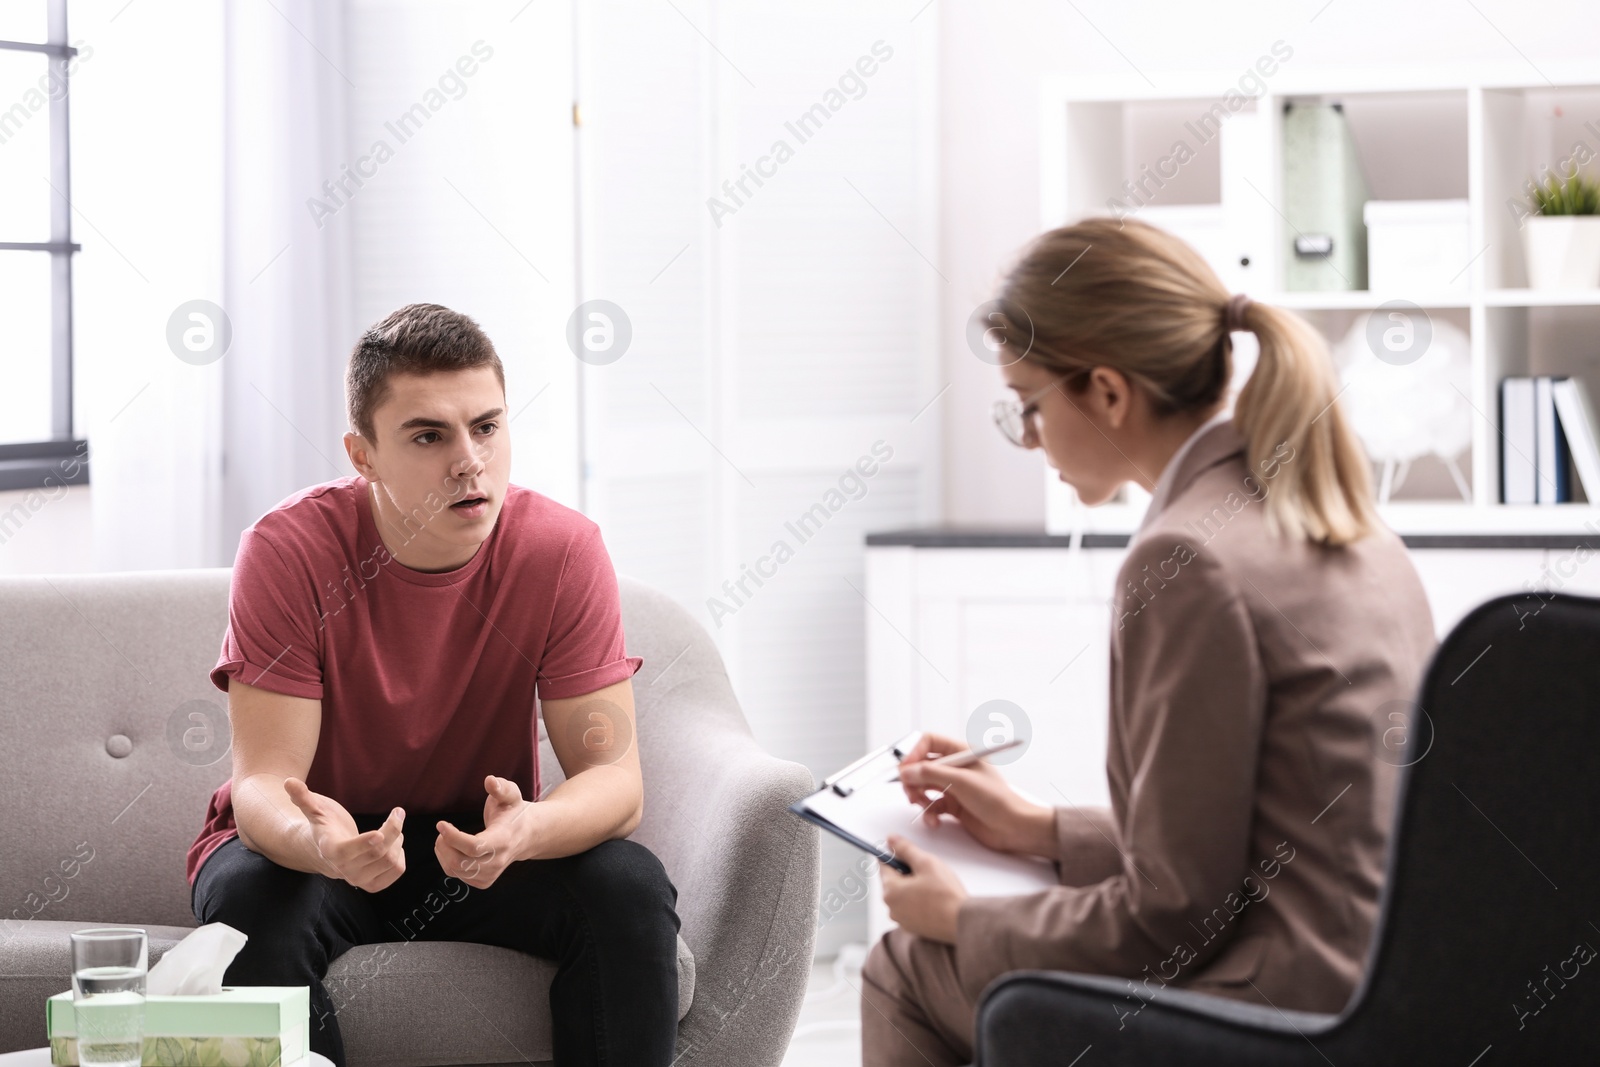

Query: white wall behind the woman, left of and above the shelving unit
(920, 0), (1600, 528)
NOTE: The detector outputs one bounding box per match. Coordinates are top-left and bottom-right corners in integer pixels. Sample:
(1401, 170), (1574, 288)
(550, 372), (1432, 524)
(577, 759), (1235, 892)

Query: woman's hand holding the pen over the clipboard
(899, 733), (1056, 859)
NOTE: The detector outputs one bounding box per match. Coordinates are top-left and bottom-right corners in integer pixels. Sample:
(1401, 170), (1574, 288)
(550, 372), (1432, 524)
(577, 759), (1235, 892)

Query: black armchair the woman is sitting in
(976, 593), (1600, 1067)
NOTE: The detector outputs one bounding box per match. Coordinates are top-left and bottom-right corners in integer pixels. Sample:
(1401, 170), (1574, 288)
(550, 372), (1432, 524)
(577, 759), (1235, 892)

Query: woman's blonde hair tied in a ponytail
(998, 218), (1378, 545)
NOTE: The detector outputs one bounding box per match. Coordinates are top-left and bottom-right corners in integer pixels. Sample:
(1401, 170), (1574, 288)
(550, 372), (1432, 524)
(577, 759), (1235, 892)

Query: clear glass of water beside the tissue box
(72, 926), (150, 1067)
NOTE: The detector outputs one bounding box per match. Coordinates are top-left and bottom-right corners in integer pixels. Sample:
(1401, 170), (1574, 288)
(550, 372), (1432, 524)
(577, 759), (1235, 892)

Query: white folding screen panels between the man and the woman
(578, 0), (944, 950)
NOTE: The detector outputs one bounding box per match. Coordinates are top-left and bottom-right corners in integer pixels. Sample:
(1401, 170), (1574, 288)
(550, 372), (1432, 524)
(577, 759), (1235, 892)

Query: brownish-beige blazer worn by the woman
(955, 422), (1435, 1016)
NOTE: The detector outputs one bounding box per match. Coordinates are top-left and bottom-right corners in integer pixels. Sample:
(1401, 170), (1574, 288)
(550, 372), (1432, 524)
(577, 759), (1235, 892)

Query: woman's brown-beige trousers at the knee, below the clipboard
(861, 928), (978, 1067)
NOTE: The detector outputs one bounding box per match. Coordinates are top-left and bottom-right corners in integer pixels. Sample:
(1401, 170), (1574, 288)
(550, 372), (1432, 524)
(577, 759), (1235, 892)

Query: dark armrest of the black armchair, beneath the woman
(976, 971), (1341, 1067)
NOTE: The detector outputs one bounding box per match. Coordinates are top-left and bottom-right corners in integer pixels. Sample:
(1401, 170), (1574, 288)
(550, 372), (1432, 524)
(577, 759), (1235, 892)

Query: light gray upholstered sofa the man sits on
(0, 568), (819, 1067)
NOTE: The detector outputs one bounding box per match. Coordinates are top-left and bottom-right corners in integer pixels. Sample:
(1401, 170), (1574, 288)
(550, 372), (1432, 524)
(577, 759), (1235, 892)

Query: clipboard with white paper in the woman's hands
(789, 731), (1061, 896)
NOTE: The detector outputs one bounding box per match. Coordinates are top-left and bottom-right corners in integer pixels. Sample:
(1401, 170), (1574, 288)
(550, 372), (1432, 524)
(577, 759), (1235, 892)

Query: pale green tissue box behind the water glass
(45, 985), (310, 1067)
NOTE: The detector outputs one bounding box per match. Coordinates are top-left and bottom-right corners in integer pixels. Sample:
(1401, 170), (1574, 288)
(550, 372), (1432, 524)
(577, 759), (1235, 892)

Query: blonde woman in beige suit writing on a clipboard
(861, 219), (1435, 1067)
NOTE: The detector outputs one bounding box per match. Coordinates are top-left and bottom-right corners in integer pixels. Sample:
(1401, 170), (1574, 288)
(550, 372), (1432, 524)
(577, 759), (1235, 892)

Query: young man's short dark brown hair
(344, 304), (506, 442)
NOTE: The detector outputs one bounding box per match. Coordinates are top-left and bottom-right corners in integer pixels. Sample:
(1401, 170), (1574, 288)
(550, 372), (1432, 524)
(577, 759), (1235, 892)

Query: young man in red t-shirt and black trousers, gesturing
(187, 304), (678, 1067)
